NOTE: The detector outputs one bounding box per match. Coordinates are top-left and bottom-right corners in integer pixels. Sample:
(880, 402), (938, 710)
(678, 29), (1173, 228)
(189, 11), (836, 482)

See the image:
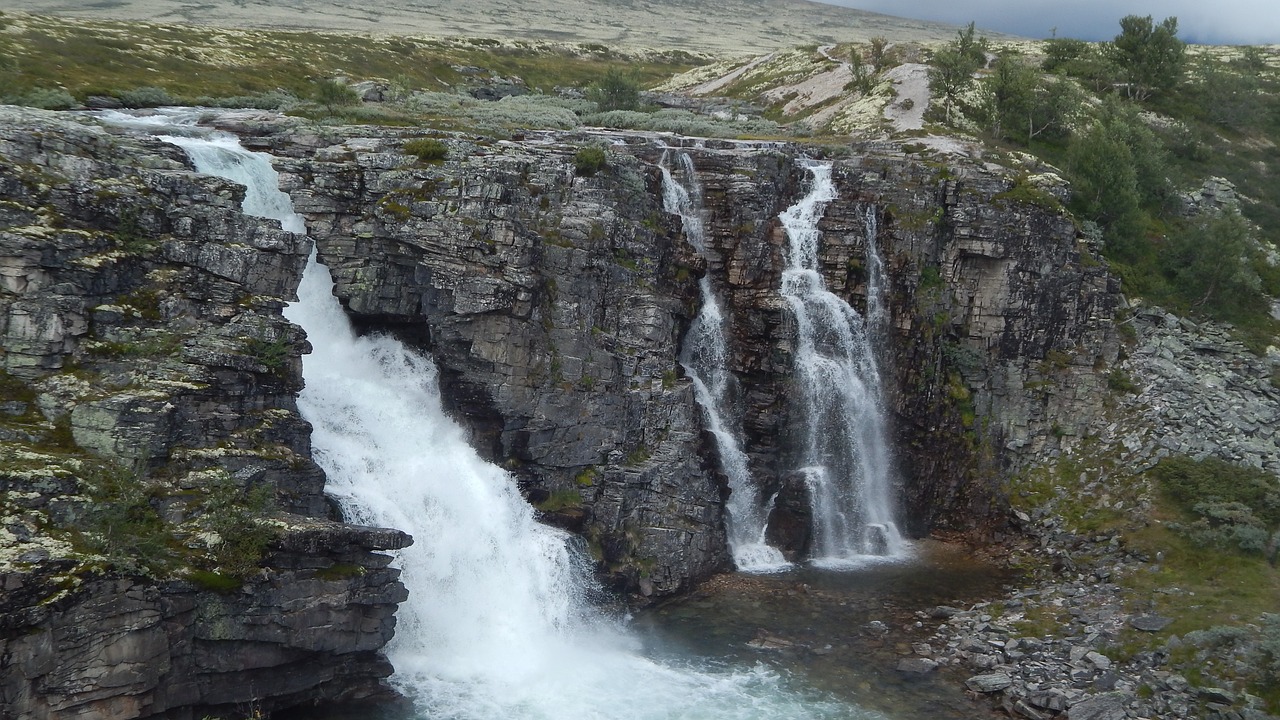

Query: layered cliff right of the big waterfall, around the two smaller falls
(257, 127), (1120, 576)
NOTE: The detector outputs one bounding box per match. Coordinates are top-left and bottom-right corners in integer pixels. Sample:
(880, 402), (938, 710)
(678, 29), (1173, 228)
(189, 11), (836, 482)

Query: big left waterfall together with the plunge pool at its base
(124, 110), (998, 720)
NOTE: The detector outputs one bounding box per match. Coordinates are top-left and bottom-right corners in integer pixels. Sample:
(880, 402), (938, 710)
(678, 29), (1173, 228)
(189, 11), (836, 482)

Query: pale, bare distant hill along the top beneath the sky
(0, 0), (995, 55)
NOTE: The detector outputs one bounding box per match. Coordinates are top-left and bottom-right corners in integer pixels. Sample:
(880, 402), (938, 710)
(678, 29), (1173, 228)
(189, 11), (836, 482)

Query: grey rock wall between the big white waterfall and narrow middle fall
(250, 128), (727, 594)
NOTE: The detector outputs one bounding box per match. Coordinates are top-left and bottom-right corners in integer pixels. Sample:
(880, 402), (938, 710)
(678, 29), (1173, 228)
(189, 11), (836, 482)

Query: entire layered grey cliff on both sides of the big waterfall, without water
(0, 109), (1120, 719)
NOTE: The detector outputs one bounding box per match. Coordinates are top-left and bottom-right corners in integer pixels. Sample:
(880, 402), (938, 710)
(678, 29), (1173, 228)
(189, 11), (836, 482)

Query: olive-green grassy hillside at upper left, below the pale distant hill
(0, 13), (707, 101)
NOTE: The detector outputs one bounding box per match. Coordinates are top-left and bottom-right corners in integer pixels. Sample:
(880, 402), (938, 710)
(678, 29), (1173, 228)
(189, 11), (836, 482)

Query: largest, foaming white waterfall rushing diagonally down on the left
(152, 120), (878, 720)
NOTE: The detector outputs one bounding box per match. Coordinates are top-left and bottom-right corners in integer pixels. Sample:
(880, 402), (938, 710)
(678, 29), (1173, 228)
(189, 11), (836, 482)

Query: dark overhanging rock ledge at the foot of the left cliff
(0, 524), (407, 720)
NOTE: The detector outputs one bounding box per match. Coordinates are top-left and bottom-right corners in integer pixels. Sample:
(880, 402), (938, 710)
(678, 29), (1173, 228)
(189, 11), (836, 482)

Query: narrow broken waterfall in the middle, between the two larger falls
(659, 151), (791, 573)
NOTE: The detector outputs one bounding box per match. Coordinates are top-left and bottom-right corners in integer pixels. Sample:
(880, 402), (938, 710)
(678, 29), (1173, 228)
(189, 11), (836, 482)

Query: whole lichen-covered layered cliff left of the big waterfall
(0, 108), (410, 720)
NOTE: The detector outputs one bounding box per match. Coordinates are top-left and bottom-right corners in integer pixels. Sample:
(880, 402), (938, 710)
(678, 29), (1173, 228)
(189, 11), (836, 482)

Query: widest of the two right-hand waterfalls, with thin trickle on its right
(780, 163), (906, 566)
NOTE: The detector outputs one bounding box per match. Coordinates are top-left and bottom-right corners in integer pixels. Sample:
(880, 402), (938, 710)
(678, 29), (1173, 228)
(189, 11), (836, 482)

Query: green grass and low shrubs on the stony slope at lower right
(1006, 447), (1280, 711)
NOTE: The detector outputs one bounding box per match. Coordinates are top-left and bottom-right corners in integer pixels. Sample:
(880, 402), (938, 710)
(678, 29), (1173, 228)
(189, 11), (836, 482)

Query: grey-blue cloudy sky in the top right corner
(819, 0), (1280, 45)
